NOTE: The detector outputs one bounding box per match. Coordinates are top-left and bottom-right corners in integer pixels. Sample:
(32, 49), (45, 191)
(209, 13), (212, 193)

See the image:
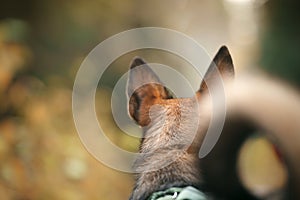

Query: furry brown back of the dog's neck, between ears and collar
(131, 98), (206, 199)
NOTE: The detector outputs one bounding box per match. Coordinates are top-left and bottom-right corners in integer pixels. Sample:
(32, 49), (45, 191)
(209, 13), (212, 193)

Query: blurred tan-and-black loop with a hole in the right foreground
(203, 73), (300, 200)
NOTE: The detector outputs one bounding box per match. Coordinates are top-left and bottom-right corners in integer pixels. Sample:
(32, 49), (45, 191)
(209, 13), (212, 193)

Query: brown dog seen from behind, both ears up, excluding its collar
(127, 46), (241, 200)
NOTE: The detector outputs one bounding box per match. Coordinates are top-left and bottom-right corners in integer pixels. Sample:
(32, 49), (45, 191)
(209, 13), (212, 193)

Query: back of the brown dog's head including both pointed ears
(127, 46), (234, 149)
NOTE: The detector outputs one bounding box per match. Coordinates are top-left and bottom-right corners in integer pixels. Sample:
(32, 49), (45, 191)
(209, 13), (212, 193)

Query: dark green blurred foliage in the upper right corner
(261, 0), (300, 87)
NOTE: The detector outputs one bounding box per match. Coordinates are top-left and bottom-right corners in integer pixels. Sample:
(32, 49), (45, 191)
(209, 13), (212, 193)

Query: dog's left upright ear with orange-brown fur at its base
(127, 57), (172, 126)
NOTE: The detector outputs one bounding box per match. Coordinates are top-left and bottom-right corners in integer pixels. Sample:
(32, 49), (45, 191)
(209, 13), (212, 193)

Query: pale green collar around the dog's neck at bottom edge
(148, 186), (207, 200)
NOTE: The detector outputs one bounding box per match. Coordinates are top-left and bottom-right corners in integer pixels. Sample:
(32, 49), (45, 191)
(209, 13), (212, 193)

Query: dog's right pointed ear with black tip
(199, 46), (234, 93)
